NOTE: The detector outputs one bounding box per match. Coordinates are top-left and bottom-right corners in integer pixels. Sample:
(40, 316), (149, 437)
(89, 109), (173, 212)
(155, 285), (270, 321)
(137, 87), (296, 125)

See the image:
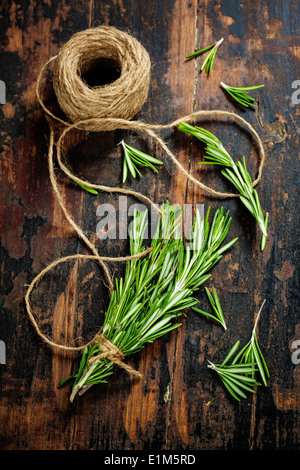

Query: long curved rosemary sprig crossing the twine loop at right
(178, 122), (269, 251)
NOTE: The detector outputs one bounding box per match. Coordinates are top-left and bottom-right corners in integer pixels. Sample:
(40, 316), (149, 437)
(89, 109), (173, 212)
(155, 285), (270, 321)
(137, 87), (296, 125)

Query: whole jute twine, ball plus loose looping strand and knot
(25, 26), (265, 377)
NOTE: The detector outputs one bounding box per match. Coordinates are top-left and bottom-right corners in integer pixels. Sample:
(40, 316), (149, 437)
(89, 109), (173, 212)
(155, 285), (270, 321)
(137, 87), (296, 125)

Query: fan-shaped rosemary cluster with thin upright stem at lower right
(208, 301), (270, 401)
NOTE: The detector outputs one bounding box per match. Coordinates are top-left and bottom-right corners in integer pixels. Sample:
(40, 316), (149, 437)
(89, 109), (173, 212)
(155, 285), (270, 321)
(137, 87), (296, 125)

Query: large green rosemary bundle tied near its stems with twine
(59, 204), (237, 402)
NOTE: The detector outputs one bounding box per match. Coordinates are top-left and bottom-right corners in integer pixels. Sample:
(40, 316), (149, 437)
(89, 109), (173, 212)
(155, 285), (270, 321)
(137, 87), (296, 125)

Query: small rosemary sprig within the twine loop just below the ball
(121, 140), (163, 183)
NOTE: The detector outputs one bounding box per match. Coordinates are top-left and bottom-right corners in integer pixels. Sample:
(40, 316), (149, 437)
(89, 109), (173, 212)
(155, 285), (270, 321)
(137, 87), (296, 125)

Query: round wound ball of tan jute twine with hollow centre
(53, 26), (151, 131)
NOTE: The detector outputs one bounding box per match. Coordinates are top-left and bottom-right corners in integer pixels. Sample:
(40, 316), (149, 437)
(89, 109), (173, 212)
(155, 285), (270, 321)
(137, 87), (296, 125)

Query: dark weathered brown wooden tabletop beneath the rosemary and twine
(0, 0), (300, 450)
